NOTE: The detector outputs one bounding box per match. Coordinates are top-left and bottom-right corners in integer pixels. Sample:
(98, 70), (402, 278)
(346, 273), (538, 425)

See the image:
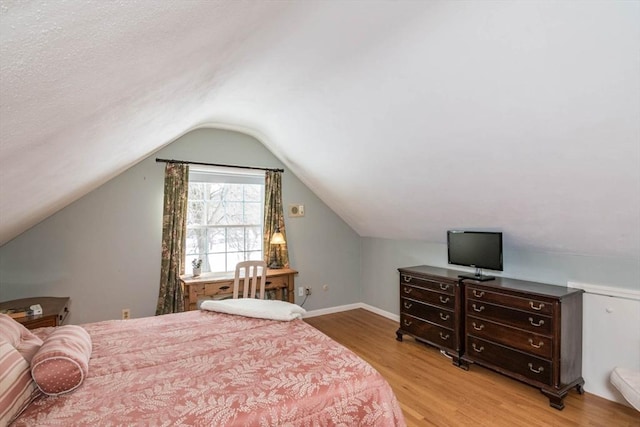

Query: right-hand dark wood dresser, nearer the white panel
(463, 278), (584, 409)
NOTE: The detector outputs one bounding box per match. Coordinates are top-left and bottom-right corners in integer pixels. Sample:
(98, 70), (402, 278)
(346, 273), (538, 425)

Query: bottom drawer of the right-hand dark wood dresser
(467, 336), (553, 386)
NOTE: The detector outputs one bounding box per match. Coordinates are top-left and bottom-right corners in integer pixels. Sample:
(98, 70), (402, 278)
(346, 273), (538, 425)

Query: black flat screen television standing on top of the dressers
(447, 230), (502, 282)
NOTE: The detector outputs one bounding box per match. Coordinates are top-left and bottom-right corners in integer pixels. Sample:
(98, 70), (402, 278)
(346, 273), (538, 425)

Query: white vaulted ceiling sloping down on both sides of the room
(0, 0), (640, 258)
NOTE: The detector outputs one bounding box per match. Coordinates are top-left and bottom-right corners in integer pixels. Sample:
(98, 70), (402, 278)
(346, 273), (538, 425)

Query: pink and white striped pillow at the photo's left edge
(0, 340), (38, 426)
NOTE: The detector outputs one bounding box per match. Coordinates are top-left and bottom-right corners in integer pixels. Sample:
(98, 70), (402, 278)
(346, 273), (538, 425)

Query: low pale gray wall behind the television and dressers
(361, 237), (640, 314)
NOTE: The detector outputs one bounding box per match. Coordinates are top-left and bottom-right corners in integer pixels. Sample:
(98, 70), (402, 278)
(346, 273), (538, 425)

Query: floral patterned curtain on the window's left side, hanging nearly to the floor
(156, 163), (189, 315)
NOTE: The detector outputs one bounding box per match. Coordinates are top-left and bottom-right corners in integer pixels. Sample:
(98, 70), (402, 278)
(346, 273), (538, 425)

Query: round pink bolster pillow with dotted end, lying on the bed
(31, 325), (92, 396)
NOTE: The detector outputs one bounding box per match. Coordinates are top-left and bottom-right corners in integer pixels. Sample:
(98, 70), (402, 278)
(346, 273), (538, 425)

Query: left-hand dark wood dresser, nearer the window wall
(396, 265), (462, 366)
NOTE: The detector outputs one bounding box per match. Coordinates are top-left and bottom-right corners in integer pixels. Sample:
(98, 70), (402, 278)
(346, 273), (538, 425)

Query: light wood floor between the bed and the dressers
(305, 309), (640, 427)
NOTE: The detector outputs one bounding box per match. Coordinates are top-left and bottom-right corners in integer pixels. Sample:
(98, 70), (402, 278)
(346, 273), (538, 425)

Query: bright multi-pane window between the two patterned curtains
(185, 166), (264, 273)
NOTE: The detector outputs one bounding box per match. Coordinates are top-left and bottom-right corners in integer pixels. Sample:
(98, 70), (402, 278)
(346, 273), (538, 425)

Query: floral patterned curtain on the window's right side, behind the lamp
(262, 171), (289, 268)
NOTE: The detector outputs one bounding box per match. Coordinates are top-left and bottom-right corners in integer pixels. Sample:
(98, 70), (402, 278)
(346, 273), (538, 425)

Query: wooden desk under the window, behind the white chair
(180, 268), (298, 310)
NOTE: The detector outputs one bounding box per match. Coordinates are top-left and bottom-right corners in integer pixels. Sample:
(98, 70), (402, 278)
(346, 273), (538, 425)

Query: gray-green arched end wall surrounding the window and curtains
(0, 129), (360, 323)
